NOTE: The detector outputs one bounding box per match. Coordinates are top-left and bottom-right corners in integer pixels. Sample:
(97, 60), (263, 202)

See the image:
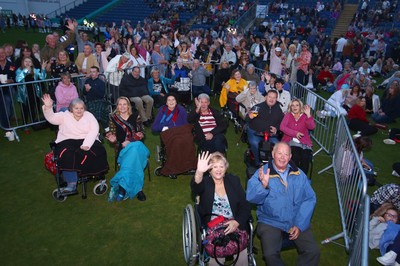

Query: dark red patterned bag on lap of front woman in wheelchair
(203, 217), (249, 265)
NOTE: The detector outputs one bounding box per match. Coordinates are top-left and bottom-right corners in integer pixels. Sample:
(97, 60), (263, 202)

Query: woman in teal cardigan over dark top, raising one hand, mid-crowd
(147, 64), (175, 108)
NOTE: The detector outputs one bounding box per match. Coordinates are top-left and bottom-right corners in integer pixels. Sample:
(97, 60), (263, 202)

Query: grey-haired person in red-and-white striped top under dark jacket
(188, 93), (228, 154)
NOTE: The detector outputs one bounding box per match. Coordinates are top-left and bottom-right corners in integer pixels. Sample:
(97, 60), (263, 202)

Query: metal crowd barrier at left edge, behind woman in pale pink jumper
(0, 75), (84, 141)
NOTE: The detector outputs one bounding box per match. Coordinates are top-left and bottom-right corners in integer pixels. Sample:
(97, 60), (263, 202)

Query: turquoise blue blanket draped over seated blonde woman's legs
(110, 141), (150, 200)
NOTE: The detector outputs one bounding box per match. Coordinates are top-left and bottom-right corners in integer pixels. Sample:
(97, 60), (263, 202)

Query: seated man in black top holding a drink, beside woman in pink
(246, 90), (283, 165)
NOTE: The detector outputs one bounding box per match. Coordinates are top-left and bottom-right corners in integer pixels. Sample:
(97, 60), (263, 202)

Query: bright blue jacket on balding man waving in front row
(246, 160), (316, 232)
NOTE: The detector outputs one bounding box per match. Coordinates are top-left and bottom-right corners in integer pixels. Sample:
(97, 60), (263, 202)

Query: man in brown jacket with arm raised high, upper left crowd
(40, 20), (75, 64)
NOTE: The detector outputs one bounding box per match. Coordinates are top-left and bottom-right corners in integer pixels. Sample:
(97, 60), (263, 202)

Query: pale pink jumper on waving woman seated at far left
(42, 105), (99, 148)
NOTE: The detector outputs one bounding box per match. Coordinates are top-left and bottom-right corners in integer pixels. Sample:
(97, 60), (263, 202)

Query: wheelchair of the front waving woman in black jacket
(182, 203), (256, 266)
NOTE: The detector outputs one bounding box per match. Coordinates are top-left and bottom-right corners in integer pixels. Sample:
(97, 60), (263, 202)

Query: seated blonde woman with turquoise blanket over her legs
(106, 97), (150, 201)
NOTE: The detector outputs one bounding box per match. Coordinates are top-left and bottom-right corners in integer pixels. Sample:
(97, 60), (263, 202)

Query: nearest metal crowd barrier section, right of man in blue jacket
(322, 116), (369, 265)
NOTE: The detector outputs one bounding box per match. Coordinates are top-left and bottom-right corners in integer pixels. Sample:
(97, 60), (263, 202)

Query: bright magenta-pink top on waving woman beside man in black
(280, 112), (315, 147)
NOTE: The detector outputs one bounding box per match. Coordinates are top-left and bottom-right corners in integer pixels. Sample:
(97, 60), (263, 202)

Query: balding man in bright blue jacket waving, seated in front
(246, 142), (320, 266)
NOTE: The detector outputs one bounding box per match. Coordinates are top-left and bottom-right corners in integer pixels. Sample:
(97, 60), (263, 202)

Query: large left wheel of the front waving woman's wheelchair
(182, 204), (197, 266)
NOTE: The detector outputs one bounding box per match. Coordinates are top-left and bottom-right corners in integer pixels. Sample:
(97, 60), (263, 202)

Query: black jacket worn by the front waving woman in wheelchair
(191, 173), (251, 231)
